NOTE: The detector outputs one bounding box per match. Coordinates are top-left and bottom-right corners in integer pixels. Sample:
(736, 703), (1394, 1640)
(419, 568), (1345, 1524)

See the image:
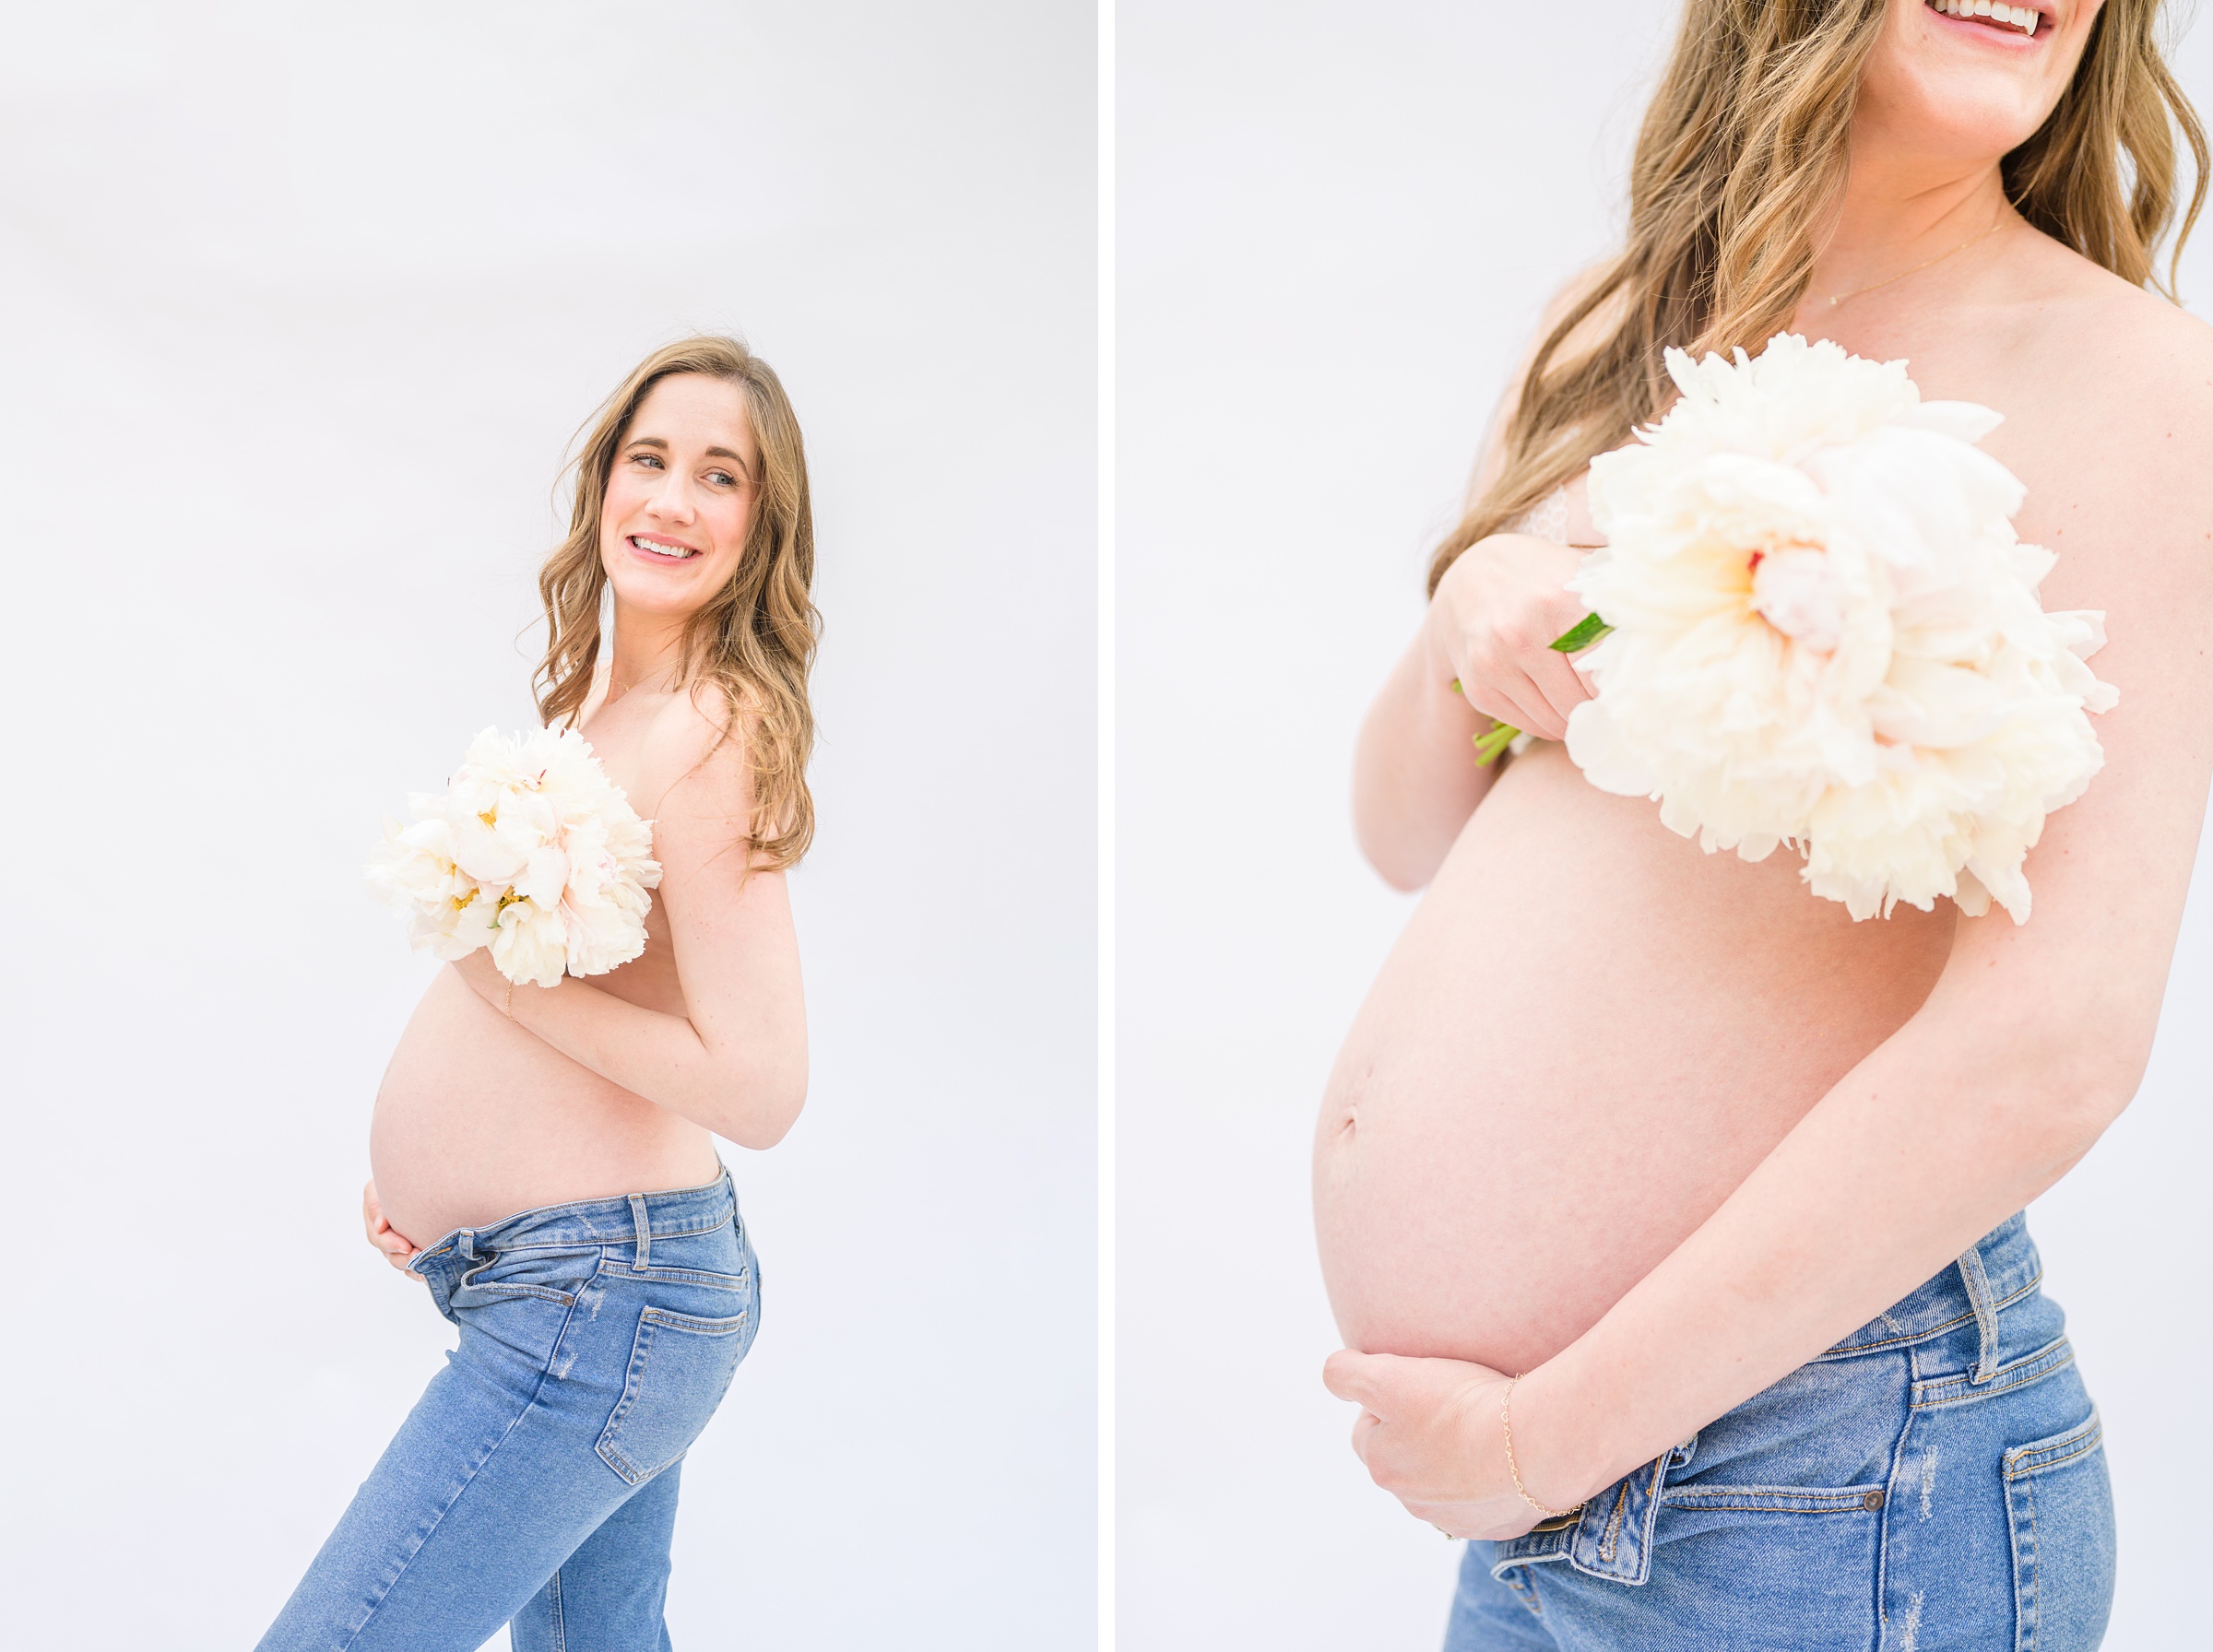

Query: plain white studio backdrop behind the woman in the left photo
(0, 0), (1095, 1652)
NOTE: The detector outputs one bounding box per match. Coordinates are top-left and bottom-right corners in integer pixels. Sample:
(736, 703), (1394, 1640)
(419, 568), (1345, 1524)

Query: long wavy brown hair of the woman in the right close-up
(1429, 0), (2207, 593)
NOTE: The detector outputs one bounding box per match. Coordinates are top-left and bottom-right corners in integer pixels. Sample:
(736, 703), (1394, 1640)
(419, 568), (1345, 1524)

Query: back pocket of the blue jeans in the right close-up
(2003, 1409), (2113, 1652)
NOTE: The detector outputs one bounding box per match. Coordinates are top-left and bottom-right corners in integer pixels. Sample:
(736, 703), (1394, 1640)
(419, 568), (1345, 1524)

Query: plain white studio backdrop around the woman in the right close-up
(1118, 0), (2213, 1652)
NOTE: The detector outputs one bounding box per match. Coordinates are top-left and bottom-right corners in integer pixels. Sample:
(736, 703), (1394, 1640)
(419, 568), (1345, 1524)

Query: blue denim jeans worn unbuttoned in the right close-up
(1445, 1216), (2113, 1652)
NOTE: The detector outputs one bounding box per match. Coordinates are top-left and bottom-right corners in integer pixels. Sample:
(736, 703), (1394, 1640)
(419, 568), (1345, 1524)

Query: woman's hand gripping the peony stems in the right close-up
(1423, 533), (1592, 741)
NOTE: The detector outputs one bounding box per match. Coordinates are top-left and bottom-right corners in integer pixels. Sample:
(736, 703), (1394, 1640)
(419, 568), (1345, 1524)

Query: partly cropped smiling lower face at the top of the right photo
(1852, 0), (2104, 166)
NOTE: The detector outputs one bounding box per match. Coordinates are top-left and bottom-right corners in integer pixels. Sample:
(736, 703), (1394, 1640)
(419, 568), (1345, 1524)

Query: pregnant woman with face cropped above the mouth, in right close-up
(1315, 0), (2213, 1652)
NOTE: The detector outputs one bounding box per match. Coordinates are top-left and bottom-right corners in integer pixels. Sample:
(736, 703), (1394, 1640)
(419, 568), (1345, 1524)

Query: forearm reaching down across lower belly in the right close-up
(1514, 995), (2134, 1502)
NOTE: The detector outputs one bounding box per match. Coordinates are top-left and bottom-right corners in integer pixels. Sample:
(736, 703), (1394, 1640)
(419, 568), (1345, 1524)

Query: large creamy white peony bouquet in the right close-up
(1567, 334), (2118, 922)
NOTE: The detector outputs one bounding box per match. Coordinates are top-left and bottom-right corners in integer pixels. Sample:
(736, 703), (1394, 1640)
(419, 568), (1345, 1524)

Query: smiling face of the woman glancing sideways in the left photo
(599, 373), (762, 620)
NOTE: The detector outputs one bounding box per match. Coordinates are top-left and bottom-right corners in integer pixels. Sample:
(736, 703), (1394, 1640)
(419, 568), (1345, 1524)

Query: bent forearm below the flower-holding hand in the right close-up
(1352, 634), (1496, 889)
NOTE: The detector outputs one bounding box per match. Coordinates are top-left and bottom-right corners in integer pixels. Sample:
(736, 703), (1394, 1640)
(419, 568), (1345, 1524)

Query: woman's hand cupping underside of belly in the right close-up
(1321, 1349), (1544, 1540)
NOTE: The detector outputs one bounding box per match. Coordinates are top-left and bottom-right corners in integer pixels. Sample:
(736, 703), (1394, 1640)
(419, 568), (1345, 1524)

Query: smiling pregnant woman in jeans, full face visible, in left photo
(261, 338), (817, 1652)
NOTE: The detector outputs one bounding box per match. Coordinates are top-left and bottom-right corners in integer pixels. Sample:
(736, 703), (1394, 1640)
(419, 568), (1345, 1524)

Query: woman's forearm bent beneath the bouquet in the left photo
(493, 977), (808, 1148)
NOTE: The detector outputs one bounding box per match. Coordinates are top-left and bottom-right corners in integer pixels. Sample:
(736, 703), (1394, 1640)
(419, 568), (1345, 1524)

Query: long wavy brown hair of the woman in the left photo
(531, 334), (821, 869)
